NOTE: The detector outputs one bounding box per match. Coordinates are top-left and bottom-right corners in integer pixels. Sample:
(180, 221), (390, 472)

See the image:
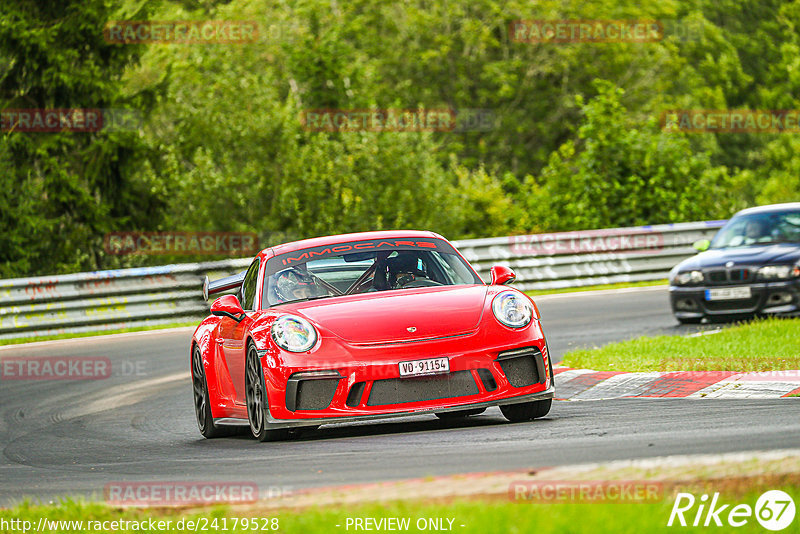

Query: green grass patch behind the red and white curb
(562, 318), (800, 371)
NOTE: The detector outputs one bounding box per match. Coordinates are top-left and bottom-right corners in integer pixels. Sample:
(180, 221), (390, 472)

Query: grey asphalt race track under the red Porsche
(0, 288), (800, 506)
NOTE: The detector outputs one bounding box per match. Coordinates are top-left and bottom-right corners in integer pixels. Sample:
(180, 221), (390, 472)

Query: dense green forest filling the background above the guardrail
(0, 0), (800, 278)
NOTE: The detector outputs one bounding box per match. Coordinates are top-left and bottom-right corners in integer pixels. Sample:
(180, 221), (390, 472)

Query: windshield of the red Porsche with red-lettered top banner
(262, 240), (483, 306)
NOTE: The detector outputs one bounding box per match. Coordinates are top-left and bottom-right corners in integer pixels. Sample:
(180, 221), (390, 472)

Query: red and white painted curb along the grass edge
(553, 366), (800, 400)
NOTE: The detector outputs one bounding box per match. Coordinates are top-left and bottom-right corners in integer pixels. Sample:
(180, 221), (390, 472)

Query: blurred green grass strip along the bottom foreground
(0, 485), (800, 534)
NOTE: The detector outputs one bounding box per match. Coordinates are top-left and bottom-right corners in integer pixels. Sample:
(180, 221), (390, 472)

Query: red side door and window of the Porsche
(219, 258), (260, 405)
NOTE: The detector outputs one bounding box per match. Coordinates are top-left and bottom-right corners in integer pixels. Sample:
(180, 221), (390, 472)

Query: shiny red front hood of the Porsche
(285, 285), (488, 343)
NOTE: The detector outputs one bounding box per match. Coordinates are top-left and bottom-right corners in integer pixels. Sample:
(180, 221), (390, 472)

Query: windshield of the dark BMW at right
(711, 210), (800, 248)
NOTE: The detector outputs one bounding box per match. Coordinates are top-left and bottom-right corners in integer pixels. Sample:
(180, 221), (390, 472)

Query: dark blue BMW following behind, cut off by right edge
(669, 202), (800, 323)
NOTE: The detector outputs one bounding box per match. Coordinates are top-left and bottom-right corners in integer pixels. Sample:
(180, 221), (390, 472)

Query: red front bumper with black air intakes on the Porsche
(214, 321), (553, 428)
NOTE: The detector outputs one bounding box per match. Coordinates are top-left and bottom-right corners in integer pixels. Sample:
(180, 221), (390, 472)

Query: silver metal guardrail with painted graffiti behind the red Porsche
(0, 221), (725, 339)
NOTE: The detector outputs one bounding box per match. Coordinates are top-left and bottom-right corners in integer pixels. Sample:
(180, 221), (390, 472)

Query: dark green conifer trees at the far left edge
(0, 0), (163, 277)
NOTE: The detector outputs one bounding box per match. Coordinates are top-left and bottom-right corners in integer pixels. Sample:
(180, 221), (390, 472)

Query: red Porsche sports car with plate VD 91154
(191, 231), (554, 441)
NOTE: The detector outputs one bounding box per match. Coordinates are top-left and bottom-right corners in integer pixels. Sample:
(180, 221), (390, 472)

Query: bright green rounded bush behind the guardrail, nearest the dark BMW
(528, 80), (735, 230)
